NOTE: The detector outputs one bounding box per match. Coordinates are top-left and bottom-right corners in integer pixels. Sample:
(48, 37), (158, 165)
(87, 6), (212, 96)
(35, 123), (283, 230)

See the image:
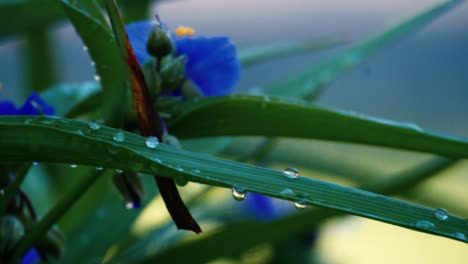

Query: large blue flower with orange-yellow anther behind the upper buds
(126, 22), (242, 96)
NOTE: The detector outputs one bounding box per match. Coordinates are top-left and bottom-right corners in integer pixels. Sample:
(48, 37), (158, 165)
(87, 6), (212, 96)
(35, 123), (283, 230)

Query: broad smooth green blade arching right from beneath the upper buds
(168, 96), (468, 158)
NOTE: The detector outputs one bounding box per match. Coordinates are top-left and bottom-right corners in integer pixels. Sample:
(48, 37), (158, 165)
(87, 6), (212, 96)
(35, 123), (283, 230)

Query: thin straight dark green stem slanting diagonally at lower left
(10, 171), (102, 260)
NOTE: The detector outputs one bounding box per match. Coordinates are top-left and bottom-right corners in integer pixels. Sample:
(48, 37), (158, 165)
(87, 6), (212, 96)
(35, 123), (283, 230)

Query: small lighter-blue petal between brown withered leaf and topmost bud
(125, 21), (153, 64)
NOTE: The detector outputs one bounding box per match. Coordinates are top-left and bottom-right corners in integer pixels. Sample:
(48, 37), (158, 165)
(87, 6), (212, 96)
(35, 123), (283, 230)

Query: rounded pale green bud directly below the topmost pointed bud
(159, 56), (186, 90)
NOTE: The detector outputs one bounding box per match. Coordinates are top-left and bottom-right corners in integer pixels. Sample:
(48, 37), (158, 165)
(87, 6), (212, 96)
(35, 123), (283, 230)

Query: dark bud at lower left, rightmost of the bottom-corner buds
(36, 225), (65, 259)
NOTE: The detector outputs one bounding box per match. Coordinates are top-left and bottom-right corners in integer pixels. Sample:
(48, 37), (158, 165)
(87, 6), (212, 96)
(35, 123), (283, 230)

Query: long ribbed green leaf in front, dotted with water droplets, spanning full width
(0, 116), (468, 242)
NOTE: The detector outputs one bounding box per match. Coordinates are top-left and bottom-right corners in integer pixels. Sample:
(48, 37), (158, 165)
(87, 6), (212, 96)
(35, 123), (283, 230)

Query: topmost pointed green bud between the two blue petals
(146, 26), (174, 58)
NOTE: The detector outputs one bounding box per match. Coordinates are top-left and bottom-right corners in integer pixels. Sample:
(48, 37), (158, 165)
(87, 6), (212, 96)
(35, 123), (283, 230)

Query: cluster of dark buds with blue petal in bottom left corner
(0, 170), (65, 263)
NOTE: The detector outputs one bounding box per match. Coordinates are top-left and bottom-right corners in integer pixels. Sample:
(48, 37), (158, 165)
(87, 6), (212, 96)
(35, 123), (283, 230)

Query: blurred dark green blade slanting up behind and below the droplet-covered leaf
(141, 156), (458, 263)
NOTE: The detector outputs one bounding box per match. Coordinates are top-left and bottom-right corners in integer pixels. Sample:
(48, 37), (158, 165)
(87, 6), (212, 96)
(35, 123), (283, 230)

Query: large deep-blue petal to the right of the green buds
(176, 37), (242, 96)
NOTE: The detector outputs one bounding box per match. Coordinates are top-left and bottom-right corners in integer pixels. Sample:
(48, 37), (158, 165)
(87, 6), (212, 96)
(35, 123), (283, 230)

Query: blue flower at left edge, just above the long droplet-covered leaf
(0, 92), (55, 115)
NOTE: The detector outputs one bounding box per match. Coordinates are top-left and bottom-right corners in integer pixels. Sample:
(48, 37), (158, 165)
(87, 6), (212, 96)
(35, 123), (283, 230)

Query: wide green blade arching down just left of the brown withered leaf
(61, 0), (128, 127)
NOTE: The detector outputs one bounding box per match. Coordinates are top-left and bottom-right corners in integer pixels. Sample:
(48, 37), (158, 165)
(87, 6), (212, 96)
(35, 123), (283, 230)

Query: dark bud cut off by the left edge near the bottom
(0, 215), (24, 259)
